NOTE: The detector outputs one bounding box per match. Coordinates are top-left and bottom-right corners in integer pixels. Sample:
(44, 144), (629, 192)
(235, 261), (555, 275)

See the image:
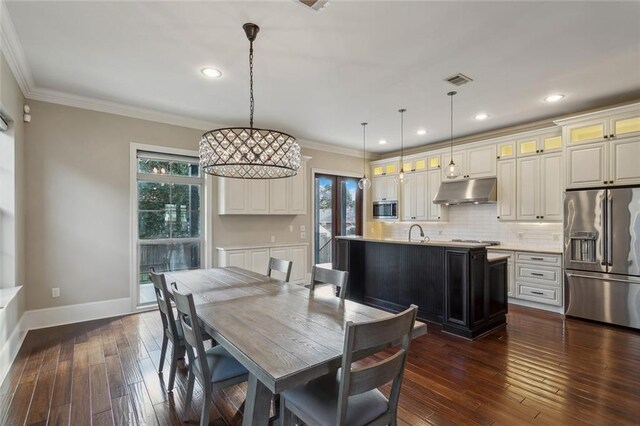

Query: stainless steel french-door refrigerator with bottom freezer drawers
(564, 187), (640, 329)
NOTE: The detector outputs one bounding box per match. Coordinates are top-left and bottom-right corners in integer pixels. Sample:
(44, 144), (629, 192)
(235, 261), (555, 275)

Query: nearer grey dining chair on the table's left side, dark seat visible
(173, 290), (249, 426)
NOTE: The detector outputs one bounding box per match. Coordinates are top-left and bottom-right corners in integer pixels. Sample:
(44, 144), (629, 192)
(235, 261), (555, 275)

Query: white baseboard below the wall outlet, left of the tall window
(22, 297), (132, 331)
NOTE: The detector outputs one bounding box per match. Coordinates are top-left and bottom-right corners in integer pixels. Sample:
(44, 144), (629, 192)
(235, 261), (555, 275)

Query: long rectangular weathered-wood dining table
(165, 267), (427, 425)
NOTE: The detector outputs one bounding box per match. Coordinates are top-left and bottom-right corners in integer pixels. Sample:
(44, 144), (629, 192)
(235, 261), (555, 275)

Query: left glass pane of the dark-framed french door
(315, 176), (334, 264)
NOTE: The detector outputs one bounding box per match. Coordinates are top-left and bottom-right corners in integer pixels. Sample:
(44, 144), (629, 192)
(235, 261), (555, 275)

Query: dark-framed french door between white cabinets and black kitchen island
(313, 174), (362, 264)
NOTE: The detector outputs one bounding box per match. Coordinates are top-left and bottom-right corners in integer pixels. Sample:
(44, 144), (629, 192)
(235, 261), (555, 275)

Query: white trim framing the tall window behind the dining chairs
(129, 142), (213, 312)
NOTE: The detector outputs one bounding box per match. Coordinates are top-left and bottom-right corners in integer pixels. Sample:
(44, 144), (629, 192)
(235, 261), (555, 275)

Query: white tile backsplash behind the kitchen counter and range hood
(366, 204), (562, 250)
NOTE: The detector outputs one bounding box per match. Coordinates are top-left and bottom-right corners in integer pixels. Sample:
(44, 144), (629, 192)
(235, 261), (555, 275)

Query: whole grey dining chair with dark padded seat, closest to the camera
(280, 305), (418, 426)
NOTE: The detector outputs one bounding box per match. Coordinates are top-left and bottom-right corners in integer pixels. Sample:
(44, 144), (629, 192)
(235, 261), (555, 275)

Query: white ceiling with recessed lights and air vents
(6, 0), (640, 152)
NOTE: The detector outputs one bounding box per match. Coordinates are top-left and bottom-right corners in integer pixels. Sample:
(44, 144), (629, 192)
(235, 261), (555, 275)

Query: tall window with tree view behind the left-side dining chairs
(136, 151), (204, 305)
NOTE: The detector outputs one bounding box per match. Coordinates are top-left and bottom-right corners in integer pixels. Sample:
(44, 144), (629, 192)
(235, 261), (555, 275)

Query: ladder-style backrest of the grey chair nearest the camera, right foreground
(336, 305), (418, 425)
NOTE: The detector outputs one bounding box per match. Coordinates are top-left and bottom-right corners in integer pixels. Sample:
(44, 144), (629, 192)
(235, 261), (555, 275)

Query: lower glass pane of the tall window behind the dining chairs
(138, 241), (201, 304)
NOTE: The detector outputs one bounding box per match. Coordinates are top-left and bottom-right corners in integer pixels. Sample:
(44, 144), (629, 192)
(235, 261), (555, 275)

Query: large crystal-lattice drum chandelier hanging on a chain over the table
(200, 23), (300, 179)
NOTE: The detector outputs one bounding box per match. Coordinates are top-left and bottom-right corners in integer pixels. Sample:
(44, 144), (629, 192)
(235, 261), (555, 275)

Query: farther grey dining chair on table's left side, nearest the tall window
(149, 271), (186, 391)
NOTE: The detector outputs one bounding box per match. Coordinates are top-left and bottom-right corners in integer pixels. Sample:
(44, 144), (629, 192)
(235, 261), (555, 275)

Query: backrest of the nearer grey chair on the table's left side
(173, 289), (211, 383)
